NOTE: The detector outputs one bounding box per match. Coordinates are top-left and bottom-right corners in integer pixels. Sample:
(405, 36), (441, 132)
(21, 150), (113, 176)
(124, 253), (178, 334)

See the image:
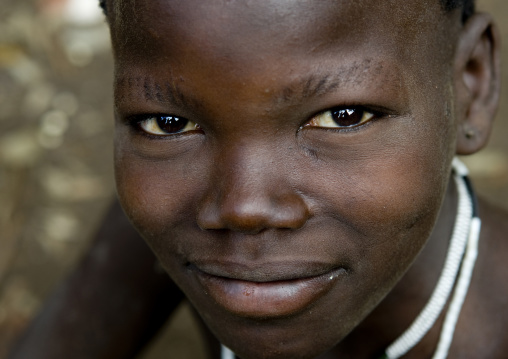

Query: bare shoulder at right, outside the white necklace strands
(454, 201), (508, 358)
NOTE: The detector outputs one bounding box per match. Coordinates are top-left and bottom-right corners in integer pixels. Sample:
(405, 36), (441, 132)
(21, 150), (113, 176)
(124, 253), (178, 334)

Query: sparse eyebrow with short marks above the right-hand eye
(275, 59), (383, 103)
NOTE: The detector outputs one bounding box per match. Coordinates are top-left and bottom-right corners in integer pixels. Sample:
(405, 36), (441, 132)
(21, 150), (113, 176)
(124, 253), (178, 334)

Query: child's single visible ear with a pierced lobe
(454, 13), (501, 155)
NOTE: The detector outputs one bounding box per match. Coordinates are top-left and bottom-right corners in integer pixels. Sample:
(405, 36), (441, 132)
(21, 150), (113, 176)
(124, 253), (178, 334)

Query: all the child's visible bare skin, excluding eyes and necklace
(5, 0), (508, 359)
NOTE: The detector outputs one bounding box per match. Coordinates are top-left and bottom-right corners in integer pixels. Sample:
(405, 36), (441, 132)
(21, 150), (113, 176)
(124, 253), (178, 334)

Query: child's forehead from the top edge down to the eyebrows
(111, 0), (453, 112)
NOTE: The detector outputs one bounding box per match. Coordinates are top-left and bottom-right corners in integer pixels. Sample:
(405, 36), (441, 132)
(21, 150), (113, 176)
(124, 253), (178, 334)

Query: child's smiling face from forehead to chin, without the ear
(112, 0), (459, 357)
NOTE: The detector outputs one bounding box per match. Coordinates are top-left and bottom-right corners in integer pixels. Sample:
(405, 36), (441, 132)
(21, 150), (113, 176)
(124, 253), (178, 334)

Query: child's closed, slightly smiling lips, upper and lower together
(192, 263), (346, 318)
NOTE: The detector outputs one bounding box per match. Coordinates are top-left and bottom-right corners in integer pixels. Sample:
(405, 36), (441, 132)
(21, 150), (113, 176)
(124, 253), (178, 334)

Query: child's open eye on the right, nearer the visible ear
(304, 108), (375, 128)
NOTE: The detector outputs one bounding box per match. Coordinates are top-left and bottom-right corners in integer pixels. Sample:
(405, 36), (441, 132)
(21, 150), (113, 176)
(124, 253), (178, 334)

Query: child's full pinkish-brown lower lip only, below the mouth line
(193, 268), (345, 318)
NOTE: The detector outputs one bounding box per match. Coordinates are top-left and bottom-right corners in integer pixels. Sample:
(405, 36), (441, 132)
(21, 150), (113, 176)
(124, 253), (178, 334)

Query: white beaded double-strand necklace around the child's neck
(221, 158), (481, 359)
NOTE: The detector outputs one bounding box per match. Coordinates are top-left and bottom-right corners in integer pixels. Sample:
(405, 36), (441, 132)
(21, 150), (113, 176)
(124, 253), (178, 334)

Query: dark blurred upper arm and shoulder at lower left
(9, 203), (183, 359)
